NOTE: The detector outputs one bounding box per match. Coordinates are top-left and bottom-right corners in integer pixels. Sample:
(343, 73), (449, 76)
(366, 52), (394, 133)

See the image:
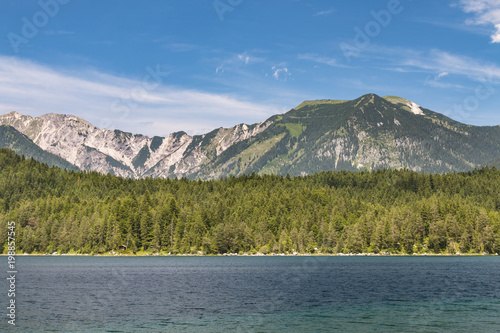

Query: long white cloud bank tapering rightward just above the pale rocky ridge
(0, 56), (279, 135)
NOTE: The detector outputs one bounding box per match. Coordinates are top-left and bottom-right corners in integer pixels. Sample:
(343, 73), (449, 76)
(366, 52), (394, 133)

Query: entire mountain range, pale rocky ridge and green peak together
(0, 94), (500, 179)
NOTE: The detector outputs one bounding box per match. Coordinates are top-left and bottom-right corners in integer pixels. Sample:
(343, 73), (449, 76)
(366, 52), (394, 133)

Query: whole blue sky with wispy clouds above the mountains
(0, 0), (500, 136)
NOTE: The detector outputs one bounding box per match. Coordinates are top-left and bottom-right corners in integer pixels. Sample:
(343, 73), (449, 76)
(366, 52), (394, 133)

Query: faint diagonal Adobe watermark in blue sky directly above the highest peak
(339, 0), (411, 63)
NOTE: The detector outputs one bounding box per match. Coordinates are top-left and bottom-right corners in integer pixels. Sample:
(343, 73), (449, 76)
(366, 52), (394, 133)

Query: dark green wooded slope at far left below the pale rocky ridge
(0, 125), (78, 171)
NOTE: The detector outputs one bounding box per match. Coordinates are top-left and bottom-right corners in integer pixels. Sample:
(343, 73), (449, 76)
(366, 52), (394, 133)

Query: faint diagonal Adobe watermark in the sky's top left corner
(7, 0), (71, 53)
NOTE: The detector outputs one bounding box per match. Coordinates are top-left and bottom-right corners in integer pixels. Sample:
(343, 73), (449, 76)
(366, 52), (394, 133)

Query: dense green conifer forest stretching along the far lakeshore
(0, 149), (500, 255)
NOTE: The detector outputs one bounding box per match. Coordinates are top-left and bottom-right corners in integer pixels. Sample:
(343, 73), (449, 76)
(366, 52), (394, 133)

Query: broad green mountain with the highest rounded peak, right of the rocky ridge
(192, 94), (500, 179)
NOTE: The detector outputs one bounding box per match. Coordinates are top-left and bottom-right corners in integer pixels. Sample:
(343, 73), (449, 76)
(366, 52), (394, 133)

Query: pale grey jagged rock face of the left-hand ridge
(0, 112), (272, 178)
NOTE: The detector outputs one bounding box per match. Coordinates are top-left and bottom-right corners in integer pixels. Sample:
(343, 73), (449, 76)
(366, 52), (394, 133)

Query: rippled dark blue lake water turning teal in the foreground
(0, 256), (500, 332)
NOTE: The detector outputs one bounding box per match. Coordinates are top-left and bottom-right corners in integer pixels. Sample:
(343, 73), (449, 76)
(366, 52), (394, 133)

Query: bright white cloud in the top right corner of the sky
(460, 0), (500, 43)
